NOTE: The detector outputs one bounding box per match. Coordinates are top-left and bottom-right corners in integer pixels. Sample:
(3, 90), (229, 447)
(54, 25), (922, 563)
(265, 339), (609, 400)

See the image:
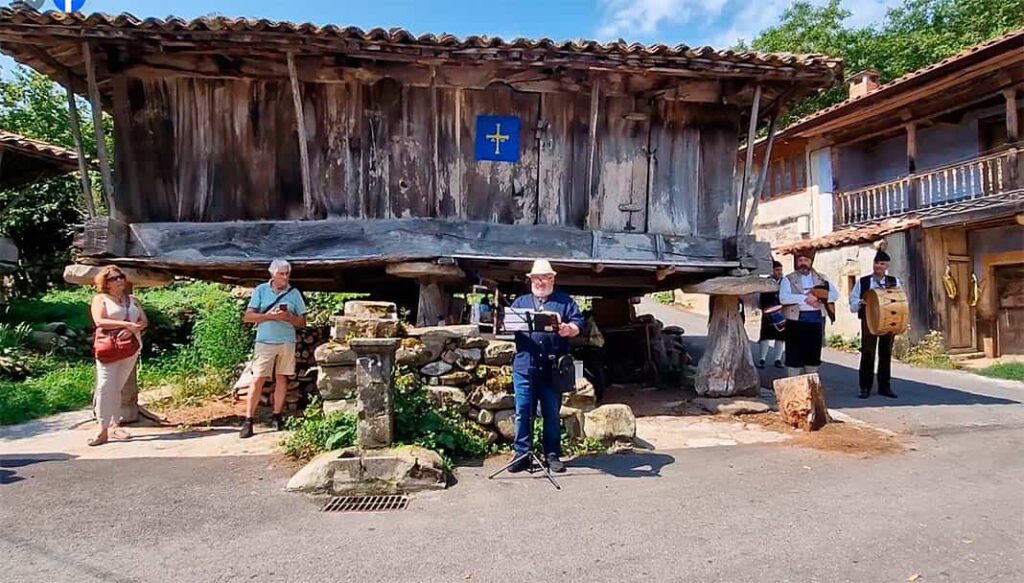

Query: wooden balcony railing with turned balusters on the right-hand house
(835, 149), (1021, 226)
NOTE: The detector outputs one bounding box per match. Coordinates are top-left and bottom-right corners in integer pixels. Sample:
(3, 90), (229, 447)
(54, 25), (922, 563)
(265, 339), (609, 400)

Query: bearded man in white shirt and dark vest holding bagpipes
(778, 249), (839, 376)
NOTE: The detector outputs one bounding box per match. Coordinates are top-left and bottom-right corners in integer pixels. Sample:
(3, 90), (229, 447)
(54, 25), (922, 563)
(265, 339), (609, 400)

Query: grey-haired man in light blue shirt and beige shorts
(239, 259), (306, 440)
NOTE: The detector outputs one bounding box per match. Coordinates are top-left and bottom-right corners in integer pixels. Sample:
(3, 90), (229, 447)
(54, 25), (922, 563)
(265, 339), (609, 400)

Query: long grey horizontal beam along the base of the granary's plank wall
(121, 218), (734, 267)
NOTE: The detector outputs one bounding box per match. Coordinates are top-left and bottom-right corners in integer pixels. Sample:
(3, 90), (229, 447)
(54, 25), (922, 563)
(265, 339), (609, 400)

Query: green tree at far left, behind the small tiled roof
(0, 67), (113, 295)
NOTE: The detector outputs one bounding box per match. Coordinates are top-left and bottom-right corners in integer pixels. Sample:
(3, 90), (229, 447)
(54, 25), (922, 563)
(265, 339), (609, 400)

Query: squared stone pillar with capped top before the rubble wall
(349, 338), (400, 450)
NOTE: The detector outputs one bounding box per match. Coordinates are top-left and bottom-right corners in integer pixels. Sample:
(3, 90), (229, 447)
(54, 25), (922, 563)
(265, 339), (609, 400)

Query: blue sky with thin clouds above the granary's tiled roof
(29, 0), (898, 47)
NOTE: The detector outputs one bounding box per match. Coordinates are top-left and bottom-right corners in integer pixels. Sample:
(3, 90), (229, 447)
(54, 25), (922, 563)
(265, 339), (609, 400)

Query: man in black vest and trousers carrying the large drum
(850, 251), (903, 399)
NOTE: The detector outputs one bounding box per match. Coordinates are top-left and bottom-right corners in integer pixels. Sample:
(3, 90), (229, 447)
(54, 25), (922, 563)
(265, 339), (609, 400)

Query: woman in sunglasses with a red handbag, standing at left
(89, 265), (148, 446)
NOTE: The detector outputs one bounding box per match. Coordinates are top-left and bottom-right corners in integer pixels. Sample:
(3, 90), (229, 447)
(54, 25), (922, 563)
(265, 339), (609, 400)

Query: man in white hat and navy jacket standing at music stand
(509, 259), (584, 472)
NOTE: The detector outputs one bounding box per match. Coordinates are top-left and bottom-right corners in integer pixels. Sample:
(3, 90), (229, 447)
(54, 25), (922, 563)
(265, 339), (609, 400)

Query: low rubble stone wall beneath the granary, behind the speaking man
(315, 301), (596, 443)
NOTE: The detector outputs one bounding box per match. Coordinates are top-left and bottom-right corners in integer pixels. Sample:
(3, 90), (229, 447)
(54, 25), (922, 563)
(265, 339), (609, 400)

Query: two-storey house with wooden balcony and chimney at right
(740, 30), (1024, 357)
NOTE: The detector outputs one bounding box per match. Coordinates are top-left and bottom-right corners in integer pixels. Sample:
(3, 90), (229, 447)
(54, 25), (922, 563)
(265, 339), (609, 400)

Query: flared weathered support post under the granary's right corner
(695, 295), (761, 397)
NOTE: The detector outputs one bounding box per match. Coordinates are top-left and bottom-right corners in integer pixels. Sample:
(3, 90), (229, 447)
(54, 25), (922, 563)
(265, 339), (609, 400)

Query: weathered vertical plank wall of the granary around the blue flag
(114, 74), (740, 237)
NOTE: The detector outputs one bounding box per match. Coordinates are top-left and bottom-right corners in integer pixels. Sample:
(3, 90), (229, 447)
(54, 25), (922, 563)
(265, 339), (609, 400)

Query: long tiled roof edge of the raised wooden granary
(0, 5), (842, 77)
